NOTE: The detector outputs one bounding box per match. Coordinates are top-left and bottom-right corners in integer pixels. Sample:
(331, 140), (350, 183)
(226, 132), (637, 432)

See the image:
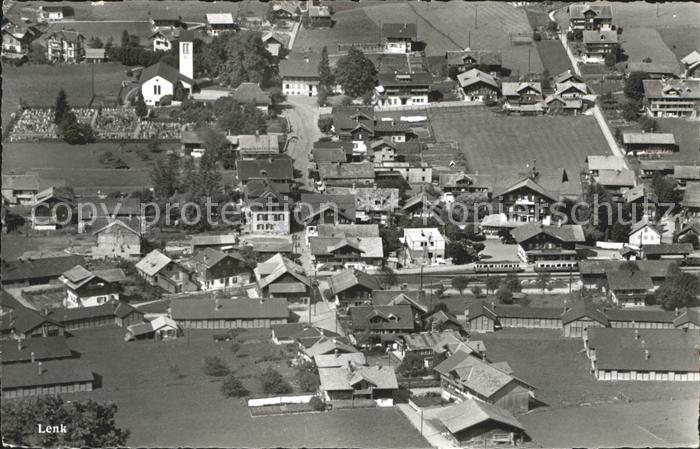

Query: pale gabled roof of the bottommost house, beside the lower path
(438, 398), (525, 434)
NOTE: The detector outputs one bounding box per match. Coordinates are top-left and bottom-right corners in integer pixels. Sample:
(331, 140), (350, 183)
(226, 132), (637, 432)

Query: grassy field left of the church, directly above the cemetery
(2, 63), (128, 124)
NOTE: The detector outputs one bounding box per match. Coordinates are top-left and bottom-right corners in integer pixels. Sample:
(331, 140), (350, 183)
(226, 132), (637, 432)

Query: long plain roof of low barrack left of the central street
(170, 298), (289, 321)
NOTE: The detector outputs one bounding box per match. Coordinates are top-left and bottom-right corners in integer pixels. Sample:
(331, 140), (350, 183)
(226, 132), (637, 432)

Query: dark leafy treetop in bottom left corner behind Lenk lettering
(2, 396), (130, 447)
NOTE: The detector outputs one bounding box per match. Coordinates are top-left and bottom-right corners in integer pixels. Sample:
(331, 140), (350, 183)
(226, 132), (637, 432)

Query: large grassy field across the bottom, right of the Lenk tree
(30, 328), (428, 448)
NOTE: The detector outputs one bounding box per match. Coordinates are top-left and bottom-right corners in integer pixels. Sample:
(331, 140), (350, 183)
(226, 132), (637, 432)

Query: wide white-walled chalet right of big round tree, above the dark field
(373, 72), (433, 106)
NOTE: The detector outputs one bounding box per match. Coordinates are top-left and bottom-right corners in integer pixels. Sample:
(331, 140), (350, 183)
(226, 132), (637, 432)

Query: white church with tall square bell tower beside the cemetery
(139, 31), (194, 106)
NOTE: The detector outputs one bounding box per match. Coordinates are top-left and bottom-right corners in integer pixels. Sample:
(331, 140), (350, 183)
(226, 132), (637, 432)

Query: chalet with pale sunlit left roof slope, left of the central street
(253, 254), (315, 302)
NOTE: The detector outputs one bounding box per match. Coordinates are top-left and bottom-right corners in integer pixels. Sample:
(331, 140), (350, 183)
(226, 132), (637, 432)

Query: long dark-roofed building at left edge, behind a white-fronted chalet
(2, 255), (85, 287)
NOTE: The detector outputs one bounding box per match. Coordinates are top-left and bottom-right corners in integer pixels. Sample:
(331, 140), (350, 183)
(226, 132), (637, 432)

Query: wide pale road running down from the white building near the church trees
(282, 95), (321, 187)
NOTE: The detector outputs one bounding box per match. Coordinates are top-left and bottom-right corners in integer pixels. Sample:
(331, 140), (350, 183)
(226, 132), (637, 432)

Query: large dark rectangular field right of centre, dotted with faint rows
(430, 107), (610, 177)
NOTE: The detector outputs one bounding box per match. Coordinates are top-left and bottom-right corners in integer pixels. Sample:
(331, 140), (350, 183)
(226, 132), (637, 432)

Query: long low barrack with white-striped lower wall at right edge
(583, 329), (700, 382)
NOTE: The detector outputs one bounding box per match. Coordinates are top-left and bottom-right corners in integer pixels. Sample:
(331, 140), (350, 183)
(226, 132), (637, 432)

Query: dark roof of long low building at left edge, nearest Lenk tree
(2, 359), (94, 390)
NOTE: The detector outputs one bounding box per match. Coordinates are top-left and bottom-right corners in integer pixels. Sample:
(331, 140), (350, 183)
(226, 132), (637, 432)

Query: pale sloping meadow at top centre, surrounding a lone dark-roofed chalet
(294, 2), (542, 75)
